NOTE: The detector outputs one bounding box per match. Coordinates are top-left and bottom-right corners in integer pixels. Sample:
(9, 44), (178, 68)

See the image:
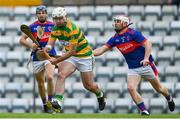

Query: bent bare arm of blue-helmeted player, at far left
(19, 33), (37, 50)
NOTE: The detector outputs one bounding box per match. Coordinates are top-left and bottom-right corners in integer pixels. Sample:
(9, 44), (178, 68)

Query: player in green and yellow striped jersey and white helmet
(45, 7), (106, 113)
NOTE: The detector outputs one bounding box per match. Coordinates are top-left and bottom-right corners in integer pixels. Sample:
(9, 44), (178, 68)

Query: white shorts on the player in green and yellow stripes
(63, 56), (94, 72)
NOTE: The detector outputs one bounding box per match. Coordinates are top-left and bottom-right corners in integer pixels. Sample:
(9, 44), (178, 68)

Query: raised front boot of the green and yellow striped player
(47, 99), (62, 113)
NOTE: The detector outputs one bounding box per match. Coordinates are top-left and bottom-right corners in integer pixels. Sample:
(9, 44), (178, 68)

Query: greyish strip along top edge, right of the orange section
(43, 0), (180, 6)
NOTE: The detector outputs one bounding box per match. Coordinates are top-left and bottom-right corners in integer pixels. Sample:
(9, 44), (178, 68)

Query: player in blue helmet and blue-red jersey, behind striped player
(20, 5), (56, 113)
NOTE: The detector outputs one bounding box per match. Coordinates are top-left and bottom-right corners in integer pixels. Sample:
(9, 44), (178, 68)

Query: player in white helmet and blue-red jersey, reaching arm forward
(93, 15), (175, 115)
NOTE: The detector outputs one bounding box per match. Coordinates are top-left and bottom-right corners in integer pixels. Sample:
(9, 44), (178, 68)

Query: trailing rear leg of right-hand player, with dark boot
(148, 76), (175, 111)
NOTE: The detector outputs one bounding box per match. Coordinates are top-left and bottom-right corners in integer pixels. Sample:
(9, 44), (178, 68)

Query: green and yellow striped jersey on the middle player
(50, 20), (92, 58)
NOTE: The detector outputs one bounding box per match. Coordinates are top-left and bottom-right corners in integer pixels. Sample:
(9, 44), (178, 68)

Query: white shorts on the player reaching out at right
(128, 63), (158, 79)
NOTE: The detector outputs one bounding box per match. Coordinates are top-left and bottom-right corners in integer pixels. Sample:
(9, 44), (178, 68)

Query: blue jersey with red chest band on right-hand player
(106, 28), (154, 69)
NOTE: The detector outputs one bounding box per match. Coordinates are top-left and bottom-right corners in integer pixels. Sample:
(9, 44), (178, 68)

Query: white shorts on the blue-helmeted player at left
(33, 60), (50, 73)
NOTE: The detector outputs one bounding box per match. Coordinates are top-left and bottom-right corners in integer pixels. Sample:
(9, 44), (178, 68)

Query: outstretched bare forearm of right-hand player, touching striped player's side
(93, 45), (110, 56)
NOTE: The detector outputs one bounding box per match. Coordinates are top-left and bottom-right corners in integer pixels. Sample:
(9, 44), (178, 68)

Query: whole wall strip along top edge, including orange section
(0, 0), (180, 6)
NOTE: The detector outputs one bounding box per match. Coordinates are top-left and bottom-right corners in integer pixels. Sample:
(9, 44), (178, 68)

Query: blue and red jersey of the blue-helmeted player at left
(29, 21), (56, 61)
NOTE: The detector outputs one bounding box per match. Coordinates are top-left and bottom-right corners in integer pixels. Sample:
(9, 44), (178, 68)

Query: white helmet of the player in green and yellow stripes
(52, 7), (67, 18)
